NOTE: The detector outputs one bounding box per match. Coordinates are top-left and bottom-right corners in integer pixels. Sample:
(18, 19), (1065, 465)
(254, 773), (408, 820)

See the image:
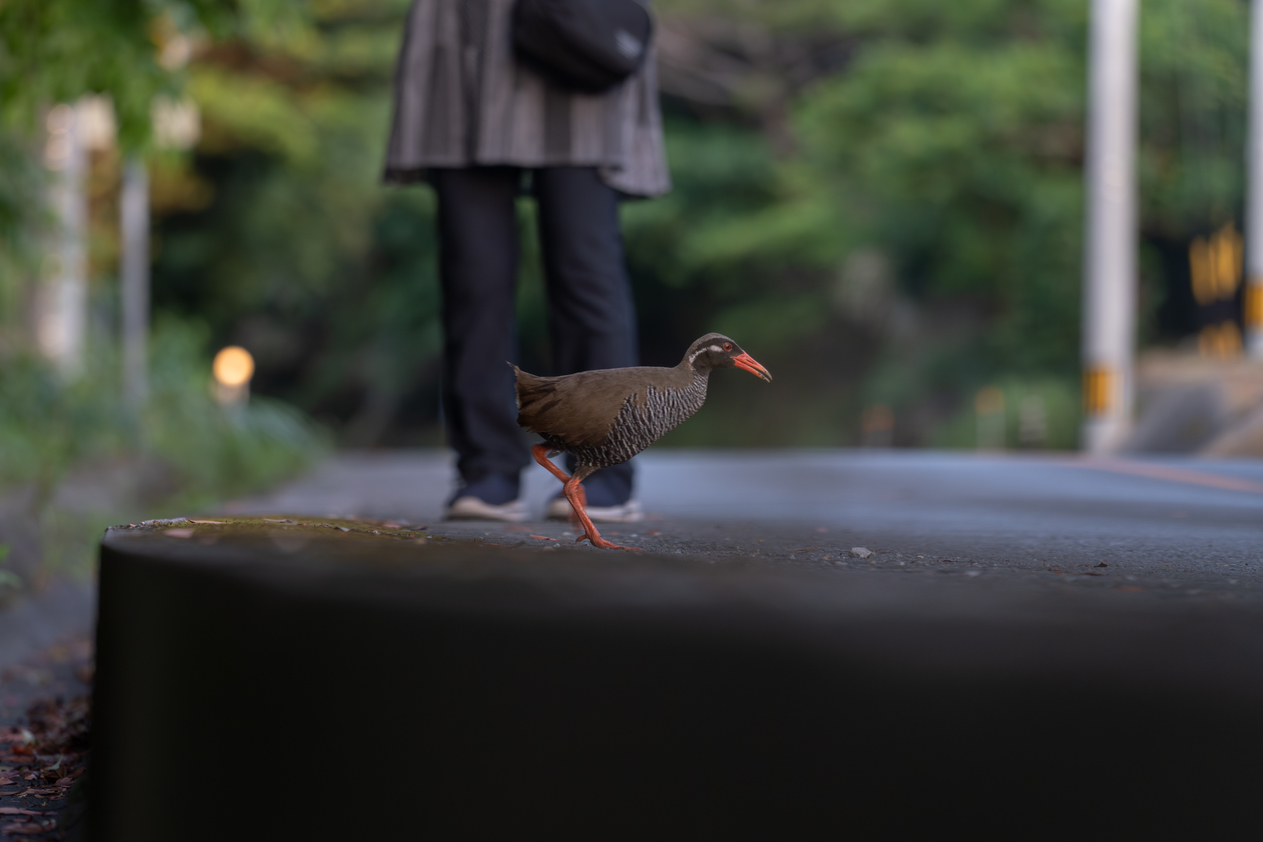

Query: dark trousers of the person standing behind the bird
(429, 167), (639, 505)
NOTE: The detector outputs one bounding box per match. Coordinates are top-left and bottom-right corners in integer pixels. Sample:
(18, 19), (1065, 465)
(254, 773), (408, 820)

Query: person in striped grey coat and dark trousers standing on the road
(384, 0), (671, 523)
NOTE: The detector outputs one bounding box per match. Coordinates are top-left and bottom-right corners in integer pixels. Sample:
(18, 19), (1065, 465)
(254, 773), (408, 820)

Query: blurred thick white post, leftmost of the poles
(35, 105), (87, 377)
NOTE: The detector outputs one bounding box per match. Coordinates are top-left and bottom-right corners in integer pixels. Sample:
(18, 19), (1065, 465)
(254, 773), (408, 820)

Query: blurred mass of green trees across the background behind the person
(0, 0), (1248, 479)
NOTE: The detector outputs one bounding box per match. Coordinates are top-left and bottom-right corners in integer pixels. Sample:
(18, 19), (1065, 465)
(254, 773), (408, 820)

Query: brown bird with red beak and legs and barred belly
(509, 333), (772, 549)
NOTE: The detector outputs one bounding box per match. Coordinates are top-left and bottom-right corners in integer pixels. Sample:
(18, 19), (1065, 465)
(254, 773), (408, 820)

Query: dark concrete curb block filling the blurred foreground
(90, 521), (1263, 842)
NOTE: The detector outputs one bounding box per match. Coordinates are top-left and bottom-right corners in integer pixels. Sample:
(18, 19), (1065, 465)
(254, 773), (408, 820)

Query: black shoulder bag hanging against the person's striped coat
(513, 0), (653, 93)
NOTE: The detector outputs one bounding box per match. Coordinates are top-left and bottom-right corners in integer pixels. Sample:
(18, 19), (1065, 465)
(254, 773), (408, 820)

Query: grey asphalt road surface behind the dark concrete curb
(238, 449), (1263, 602)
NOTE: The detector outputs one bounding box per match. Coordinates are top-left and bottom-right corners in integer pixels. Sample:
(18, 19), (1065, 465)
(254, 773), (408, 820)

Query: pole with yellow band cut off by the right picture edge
(1244, 0), (1263, 360)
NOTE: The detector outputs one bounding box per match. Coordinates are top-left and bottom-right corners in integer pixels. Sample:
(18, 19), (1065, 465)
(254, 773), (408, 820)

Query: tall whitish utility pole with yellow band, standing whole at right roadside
(1082, 0), (1139, 453)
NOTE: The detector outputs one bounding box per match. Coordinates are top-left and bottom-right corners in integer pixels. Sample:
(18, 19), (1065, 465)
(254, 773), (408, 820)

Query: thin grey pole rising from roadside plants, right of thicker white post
(119, 157), (149, 410)
